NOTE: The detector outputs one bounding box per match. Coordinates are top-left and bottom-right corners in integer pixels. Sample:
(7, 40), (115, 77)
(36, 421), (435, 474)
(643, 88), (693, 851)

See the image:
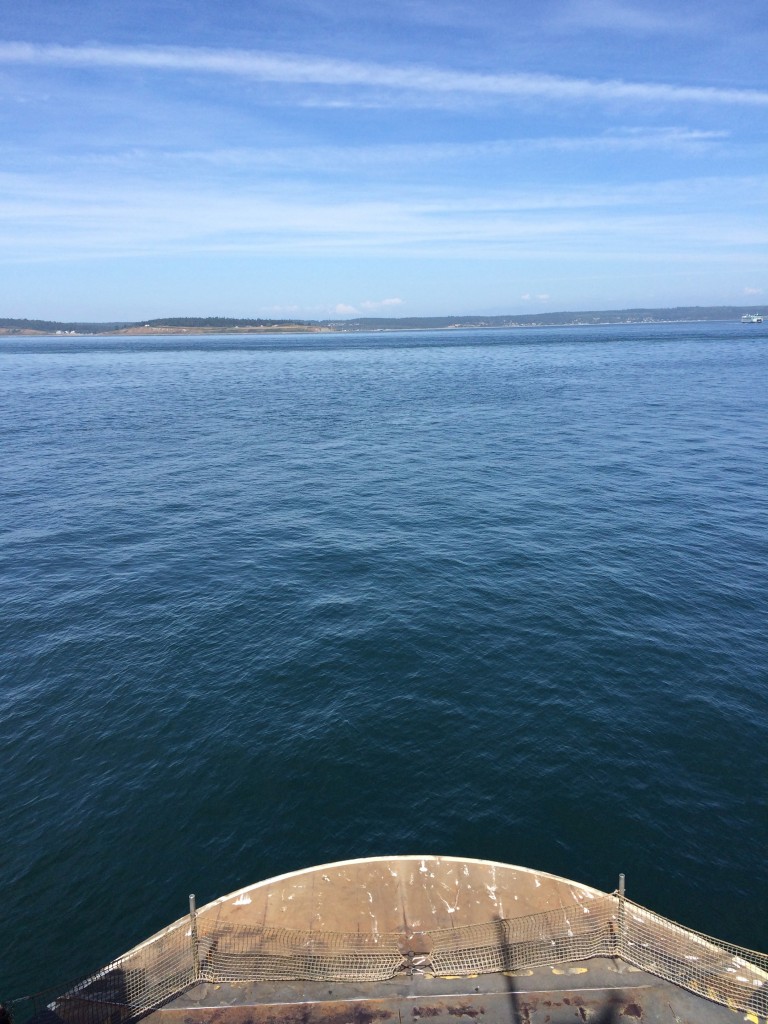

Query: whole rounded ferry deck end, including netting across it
(24, 856), (768, 1024)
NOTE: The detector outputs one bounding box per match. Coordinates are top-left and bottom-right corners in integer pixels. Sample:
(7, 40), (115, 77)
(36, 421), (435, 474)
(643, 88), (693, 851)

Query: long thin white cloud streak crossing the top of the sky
(0, 43), (768, 106)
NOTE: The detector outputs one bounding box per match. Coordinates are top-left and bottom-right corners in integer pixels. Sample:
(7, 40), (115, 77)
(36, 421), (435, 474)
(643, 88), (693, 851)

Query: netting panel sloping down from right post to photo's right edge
(620, 900), (768, 1017)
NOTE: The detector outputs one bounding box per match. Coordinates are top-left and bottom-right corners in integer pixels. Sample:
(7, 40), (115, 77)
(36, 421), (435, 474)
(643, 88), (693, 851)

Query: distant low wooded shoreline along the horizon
(0, 306), (768, 338)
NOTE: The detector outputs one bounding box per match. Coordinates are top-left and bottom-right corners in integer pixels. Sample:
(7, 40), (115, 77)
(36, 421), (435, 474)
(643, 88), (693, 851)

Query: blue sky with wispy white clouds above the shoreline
(0, 0), (768, 321)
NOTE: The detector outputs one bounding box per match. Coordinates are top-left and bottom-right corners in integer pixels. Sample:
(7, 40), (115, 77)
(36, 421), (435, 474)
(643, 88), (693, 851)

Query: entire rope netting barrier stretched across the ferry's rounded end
(11, 894), (768, 1024)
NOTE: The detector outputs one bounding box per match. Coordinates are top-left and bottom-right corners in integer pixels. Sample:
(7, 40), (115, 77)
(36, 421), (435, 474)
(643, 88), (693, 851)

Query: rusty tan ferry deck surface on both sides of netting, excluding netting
(145, 857), (768, 1024)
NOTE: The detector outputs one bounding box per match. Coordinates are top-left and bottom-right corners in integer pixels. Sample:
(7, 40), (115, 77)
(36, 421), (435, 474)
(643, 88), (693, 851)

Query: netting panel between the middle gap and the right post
(429, 897), (616, 975)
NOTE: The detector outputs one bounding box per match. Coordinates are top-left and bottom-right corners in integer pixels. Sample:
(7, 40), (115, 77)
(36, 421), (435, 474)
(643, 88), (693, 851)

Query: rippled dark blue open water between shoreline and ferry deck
(0, 324), (768, 996)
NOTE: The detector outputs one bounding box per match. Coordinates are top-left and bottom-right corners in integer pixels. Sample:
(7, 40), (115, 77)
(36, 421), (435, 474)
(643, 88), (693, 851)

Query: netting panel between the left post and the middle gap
(200, 926), (402, 982)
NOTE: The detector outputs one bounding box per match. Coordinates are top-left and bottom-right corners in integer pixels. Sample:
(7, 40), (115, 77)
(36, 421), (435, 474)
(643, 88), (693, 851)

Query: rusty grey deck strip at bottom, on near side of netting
(147, 959), (745, 1024)
